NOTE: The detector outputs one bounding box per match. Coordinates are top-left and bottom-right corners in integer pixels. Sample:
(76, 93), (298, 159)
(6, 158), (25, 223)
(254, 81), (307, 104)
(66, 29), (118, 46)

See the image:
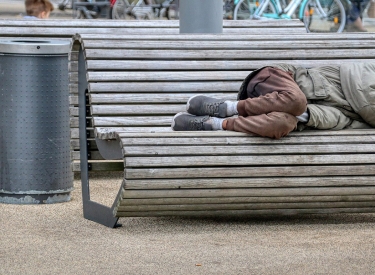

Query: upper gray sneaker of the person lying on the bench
(186, 95), (227, 117)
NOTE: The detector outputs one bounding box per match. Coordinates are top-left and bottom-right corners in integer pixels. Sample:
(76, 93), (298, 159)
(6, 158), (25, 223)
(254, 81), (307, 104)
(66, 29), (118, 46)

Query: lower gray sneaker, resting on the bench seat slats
(172, 112), (212, 131)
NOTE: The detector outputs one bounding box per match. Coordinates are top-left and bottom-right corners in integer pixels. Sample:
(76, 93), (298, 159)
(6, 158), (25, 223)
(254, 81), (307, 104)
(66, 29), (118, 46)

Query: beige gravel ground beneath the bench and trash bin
(0, 173), (375, 275)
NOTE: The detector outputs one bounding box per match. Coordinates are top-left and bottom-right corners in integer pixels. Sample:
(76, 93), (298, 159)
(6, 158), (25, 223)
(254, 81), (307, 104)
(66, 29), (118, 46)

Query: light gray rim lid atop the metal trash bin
(0, 38), (70, 55)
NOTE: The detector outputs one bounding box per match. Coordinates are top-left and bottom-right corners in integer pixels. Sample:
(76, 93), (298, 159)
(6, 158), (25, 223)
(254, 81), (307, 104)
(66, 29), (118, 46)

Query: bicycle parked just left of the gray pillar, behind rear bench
(112, 0), (178, 20)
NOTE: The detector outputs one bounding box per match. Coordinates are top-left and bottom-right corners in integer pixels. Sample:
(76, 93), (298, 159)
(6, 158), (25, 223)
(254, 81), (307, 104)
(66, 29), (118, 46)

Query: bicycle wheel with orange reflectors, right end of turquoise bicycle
(300, 0), (346, 32)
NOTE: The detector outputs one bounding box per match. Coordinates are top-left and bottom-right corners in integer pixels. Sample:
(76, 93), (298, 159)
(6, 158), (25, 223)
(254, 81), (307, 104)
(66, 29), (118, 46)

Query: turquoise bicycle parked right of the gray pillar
(234, 0), (350, 32)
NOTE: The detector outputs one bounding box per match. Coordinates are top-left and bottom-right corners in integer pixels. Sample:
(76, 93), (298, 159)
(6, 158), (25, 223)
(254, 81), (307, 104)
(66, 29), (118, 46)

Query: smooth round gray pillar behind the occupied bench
(179, 0), (223, 33)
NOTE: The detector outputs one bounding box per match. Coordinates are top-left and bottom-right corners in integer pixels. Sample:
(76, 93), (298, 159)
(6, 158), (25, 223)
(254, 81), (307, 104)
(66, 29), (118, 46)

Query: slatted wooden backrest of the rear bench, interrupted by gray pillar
(0, 19), (306, 38)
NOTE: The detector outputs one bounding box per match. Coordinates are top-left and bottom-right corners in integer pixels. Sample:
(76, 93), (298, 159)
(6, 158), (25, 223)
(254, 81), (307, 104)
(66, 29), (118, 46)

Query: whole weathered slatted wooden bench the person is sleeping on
(70, 34), (375, 227)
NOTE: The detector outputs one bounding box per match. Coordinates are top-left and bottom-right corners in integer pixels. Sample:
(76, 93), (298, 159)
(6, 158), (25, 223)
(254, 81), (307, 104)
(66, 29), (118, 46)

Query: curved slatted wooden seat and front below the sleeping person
(114, 130), (375, 217)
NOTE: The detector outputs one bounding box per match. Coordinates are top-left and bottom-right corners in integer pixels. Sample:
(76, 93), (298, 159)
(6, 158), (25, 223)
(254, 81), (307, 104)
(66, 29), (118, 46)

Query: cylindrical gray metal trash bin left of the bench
(0, 40), (73, 204)
